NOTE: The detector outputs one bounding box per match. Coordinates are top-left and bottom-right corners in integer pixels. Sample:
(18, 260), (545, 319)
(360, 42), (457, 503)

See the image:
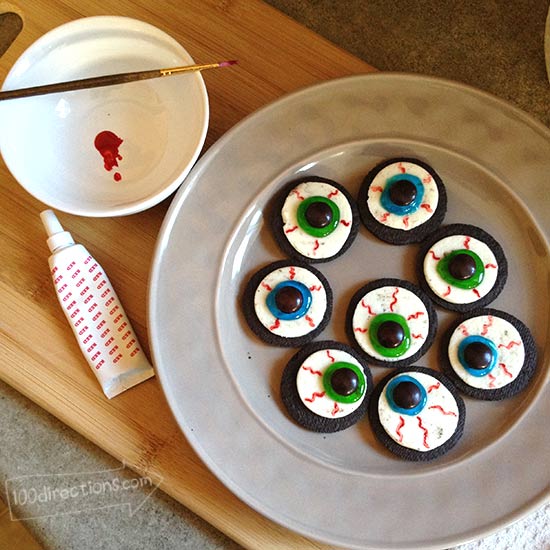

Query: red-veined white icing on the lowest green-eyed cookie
(296, 349), (366, 418)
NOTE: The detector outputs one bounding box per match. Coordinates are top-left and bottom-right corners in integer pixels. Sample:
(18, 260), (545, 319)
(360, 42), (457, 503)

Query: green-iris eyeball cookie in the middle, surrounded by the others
(346, 279), (437, 367)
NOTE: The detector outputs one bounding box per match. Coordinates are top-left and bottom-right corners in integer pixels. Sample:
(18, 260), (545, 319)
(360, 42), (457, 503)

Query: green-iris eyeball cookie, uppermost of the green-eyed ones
(272, 176), (359, 263)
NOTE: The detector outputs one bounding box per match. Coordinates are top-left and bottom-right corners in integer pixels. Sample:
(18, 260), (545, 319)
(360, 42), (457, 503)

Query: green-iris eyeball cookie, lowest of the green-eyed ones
(281, 341), (373, 433)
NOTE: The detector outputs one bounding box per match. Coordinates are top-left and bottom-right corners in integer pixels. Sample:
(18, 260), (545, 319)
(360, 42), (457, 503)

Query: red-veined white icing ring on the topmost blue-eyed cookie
(367, 162), (439, 231)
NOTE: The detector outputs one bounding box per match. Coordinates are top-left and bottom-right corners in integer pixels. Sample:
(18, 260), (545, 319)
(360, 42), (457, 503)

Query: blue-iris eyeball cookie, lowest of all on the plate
(369, 367), (466, 461)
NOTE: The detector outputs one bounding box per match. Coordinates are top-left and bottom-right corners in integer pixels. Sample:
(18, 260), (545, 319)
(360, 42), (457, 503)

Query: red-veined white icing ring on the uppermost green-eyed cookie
(281, 181), (353, 259)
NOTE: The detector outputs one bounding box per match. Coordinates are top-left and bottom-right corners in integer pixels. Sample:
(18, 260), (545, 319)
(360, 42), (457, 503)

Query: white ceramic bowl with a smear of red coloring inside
(0, 16), (208, 216)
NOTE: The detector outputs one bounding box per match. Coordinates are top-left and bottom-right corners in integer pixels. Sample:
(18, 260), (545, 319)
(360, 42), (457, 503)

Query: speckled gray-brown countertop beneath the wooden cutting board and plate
(0, 0), (550, 550)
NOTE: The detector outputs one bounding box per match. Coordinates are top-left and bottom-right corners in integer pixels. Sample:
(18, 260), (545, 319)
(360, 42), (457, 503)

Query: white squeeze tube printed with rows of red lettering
(40, 210), (155, 399)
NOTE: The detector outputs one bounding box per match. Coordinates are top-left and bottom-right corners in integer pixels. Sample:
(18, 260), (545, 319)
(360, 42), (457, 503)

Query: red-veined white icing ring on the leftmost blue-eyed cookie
(254, 266), (327, 338)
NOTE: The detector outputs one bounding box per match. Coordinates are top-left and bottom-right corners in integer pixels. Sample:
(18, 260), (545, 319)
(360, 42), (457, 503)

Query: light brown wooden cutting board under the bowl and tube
(0, 0), (373, 548)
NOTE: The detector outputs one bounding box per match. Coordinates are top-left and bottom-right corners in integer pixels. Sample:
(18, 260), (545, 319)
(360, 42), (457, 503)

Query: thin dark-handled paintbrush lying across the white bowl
(0, 61), (237, 101)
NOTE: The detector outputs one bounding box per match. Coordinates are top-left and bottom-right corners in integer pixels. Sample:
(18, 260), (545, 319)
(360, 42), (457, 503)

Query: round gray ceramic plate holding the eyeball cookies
(149, 74), (550, 549)
